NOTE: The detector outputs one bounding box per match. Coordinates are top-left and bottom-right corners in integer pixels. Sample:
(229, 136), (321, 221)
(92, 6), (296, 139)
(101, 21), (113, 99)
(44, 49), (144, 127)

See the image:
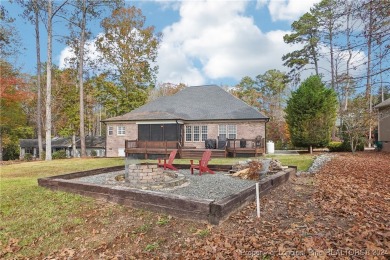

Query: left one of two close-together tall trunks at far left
(34, 0), (43, 159)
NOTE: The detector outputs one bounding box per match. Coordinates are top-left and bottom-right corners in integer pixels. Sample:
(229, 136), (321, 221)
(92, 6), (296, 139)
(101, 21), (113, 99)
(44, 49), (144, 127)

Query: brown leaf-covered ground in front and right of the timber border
(3, 152), (390, 259)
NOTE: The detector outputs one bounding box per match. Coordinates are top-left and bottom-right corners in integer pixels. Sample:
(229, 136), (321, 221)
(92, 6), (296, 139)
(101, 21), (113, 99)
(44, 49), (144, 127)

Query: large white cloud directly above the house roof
(157, 1), (298, 85)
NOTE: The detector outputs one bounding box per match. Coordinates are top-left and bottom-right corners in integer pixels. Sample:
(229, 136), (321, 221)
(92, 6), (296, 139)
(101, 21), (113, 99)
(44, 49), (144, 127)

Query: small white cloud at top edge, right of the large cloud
(257, 0), (320, 22)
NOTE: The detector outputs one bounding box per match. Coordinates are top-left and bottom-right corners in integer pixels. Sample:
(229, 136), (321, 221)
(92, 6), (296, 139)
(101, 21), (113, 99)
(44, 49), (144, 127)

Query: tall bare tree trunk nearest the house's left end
(78, 0), (87, 158)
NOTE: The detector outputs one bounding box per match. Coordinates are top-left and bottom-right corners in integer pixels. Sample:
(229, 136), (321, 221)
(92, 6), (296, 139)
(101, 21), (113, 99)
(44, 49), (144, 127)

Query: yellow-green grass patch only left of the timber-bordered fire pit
(0, 158), (124, 258)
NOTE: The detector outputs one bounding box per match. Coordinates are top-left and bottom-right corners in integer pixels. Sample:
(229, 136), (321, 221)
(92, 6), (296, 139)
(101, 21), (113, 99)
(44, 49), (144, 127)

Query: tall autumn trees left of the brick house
(0, 0), (161, 160)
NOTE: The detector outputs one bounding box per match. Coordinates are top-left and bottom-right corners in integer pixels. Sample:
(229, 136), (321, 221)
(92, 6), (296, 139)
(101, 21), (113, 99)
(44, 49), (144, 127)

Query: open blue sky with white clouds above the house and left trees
(5, 0), (318, 86)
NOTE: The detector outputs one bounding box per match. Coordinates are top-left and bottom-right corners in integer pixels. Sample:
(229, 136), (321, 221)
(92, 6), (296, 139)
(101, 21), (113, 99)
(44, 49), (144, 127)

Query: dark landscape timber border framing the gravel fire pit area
(38, 164), (297, 225)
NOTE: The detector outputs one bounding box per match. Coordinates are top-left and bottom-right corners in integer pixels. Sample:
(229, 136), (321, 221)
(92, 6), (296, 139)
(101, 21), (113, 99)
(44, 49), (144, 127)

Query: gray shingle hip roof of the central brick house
(104, 86), (268, 122)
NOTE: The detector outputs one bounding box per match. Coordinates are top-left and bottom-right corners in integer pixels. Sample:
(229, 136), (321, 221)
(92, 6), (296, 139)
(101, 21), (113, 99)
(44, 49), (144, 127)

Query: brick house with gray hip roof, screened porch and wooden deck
(103, 85), (269, 157)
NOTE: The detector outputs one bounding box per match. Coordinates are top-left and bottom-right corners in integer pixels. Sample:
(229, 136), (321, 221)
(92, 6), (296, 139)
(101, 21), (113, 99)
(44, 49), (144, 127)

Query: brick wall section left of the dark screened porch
(106, 123), (138, 157)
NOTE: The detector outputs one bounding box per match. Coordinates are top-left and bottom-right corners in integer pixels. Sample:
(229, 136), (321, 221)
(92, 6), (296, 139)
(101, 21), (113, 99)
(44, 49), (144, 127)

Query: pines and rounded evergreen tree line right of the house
(232, 0), (390, 153)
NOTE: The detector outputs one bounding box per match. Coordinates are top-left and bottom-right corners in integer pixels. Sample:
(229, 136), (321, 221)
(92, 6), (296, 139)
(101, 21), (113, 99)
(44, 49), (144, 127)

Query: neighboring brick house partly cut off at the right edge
(375, 98), (390, 152)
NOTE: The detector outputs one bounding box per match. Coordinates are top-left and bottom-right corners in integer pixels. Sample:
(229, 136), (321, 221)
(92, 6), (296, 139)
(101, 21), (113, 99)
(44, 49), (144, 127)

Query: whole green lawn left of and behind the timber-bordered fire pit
(0, 155), (313, 258)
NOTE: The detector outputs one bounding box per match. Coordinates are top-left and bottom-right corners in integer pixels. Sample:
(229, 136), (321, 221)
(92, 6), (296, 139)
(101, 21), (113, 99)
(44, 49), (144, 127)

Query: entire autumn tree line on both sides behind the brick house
(0, 0), (390, 160)
